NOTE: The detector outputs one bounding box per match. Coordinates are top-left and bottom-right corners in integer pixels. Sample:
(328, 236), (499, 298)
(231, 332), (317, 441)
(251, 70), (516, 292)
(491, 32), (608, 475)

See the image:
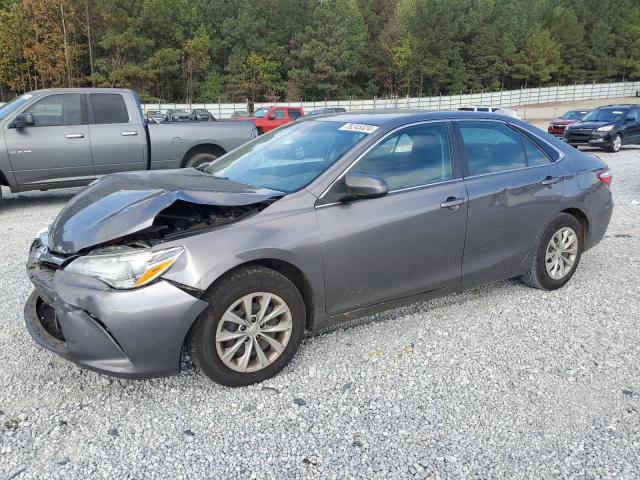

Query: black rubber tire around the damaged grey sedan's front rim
(190, 266), (306, 387)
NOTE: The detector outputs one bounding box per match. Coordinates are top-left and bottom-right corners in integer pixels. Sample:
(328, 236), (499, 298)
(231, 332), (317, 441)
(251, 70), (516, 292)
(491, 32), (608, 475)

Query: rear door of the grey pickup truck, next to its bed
(87, 93), (147, 175)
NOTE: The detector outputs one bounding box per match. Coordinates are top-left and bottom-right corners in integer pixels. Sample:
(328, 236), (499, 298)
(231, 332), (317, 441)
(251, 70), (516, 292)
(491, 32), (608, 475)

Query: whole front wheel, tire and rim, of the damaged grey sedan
(191, 267), (306, 387)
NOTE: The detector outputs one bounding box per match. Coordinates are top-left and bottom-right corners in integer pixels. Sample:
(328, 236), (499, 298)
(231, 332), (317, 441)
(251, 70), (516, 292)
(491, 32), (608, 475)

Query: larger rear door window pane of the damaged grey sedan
(458, 122), (527, 176)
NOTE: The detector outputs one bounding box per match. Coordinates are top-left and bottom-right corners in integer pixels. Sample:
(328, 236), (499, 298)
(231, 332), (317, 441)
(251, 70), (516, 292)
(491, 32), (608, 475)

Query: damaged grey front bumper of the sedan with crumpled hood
(24, 242), (208, 378)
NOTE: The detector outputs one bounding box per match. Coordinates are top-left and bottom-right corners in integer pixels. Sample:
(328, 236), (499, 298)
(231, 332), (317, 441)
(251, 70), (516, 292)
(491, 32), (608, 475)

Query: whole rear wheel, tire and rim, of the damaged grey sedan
(521, 213), (584, 290)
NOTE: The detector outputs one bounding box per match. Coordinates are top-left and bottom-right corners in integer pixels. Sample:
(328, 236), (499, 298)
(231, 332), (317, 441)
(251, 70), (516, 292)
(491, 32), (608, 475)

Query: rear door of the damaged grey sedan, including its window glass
(454, 120), (564, 282)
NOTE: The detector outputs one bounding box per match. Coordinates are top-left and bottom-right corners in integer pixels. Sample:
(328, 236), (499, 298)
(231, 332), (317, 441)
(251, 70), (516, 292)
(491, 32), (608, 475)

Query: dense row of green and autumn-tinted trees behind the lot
(0, 0), (640, 102)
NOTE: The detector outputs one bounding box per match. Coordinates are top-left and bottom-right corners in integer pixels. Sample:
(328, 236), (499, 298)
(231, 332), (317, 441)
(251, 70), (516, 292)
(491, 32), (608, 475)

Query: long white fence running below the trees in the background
(143, 82), (640, 119)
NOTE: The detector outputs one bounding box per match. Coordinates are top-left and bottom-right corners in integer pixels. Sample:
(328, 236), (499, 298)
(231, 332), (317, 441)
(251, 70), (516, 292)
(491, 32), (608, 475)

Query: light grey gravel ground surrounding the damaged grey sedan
(0, 148), (640, 479)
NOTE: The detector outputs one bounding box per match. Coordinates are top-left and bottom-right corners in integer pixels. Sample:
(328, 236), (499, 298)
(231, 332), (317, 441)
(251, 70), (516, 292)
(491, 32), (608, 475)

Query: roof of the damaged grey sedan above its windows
(309, 110), (516, 126)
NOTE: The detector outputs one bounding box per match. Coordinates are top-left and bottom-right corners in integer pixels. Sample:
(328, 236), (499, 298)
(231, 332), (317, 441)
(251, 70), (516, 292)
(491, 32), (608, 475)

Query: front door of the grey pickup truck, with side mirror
(5, 93), (94, 185)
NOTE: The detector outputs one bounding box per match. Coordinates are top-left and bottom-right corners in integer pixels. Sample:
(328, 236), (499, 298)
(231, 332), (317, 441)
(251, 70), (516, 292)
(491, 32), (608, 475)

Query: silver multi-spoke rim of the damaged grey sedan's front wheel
(215, 292), (293, 373)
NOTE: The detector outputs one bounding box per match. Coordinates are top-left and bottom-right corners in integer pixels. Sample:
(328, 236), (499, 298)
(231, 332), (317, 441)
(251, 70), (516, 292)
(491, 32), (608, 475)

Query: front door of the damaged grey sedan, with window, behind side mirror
(316, 122), (467, 314)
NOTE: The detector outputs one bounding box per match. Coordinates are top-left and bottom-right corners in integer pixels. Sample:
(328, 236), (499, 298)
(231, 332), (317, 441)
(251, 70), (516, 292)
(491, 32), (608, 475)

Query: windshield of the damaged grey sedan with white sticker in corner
(205, 121), (377, 193)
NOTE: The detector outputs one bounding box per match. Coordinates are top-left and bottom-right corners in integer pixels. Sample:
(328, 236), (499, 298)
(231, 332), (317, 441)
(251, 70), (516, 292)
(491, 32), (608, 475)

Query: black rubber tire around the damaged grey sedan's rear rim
(520, 213), (584, 290)
